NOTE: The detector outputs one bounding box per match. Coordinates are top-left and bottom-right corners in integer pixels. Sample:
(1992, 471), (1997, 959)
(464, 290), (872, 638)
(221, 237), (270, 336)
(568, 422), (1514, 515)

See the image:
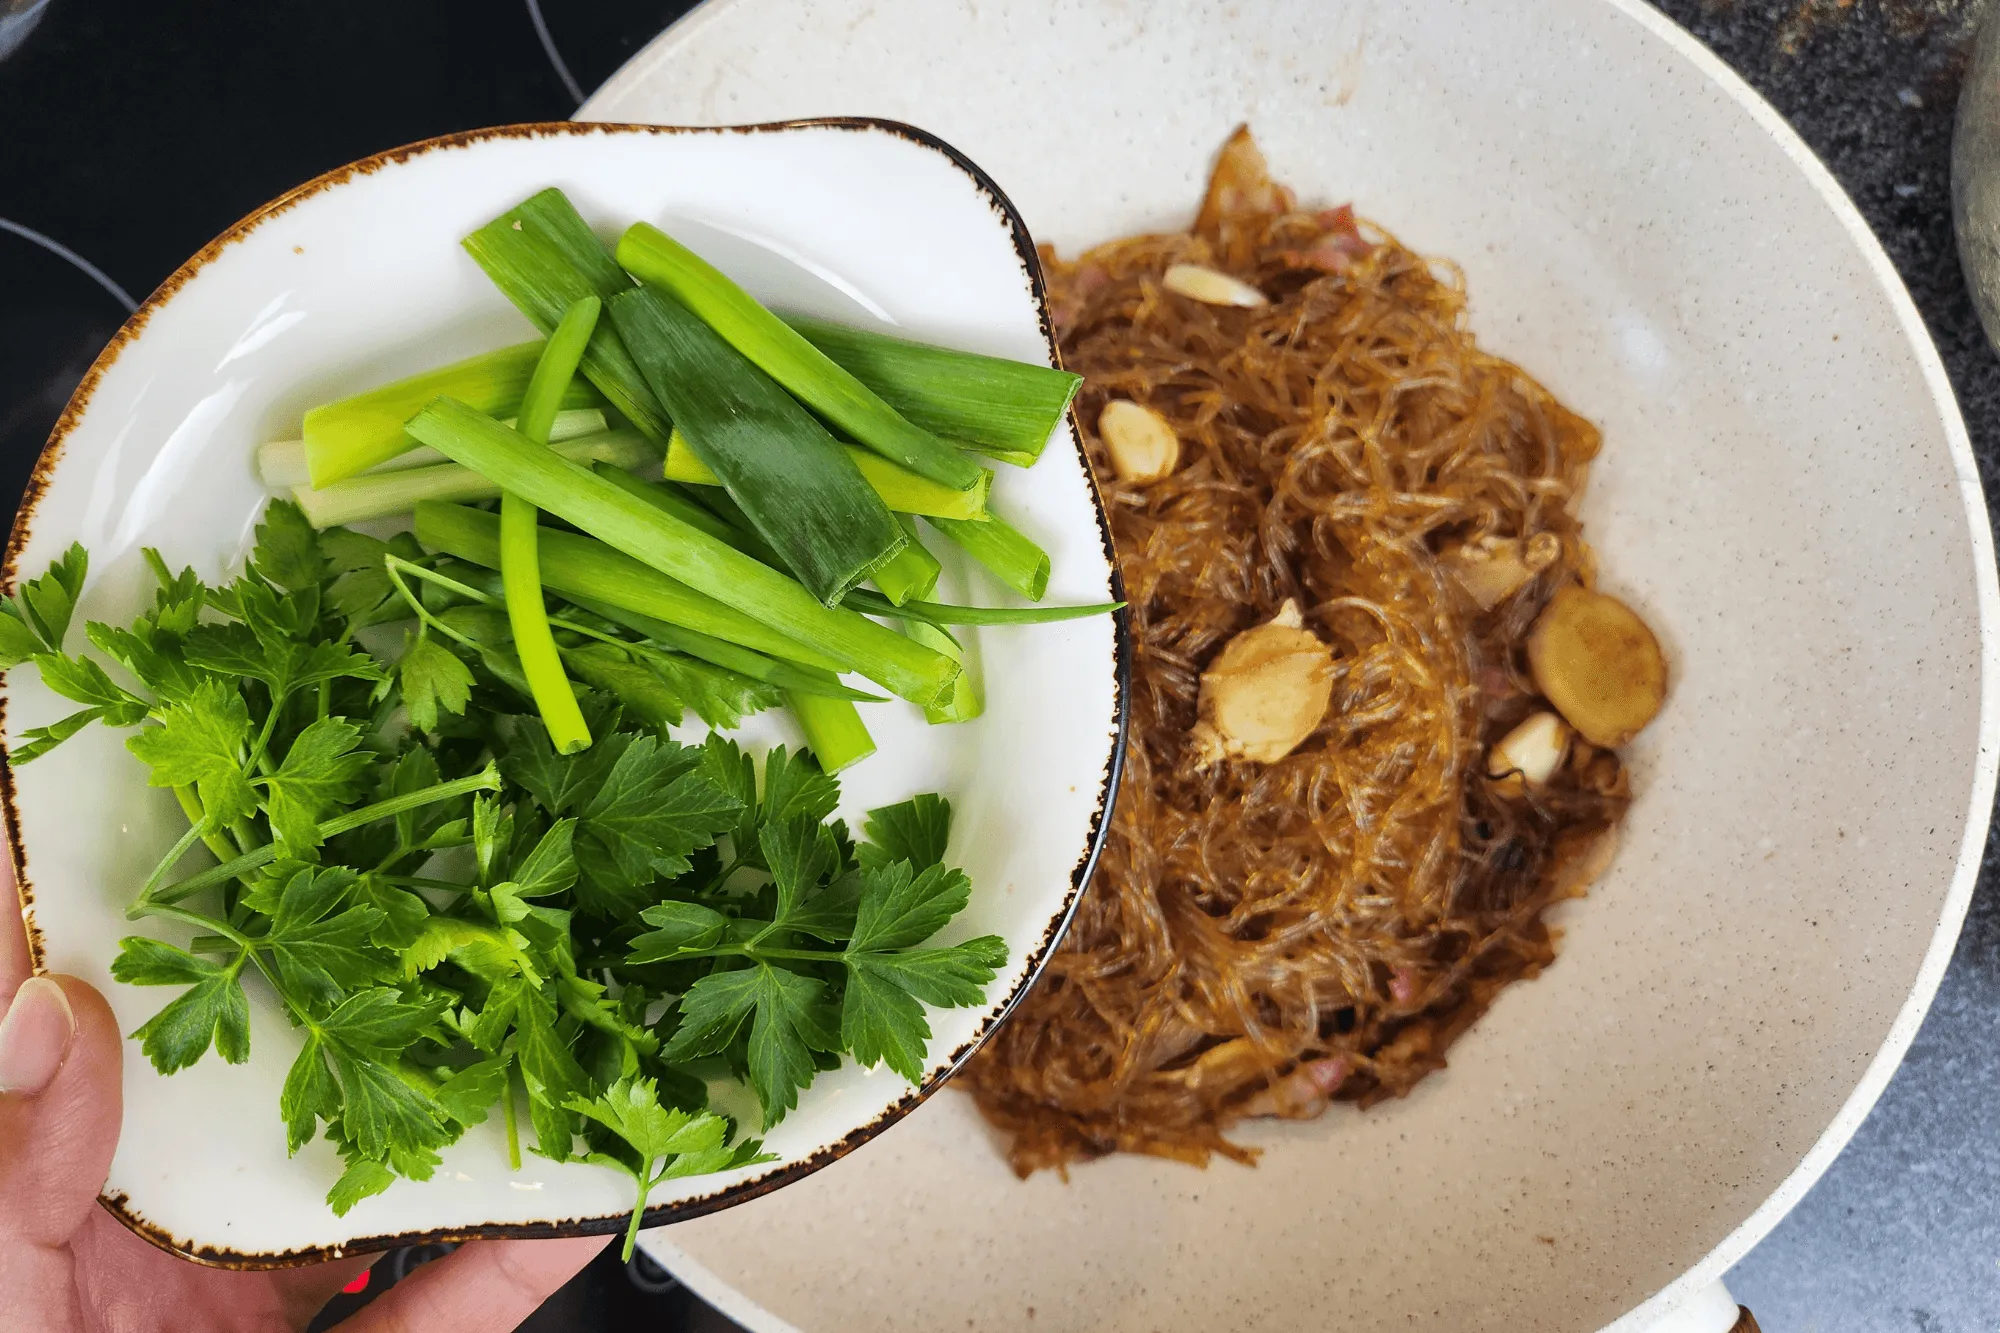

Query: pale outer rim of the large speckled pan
(576, 0), (2000, 1333)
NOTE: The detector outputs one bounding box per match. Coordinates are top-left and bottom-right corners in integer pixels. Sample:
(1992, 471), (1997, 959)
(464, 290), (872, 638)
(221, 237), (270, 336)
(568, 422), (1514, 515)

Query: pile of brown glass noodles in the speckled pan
(962, 132), (1626, 1175)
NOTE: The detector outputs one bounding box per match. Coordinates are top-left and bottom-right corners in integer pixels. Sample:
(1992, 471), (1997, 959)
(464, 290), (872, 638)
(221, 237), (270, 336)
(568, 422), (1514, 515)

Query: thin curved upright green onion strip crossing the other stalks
(500, 296), (604, 755)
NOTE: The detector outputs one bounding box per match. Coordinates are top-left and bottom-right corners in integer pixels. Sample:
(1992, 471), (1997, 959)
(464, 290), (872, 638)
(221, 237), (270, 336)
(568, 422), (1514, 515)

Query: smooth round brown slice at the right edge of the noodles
(1528, 586), (1666, 749)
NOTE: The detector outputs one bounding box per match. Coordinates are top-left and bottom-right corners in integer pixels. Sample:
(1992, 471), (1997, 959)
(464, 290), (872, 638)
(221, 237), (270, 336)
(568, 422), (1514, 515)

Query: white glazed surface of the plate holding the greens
(6, 122), (1122, 1263)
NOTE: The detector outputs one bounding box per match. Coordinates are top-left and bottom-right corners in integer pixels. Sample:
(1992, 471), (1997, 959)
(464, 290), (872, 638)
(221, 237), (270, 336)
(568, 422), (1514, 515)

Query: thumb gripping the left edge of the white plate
(0, 977), (124, 1249)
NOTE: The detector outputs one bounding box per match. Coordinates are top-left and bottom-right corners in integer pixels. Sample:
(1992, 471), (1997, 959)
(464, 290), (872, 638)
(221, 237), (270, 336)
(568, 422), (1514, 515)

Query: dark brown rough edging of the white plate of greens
(0, 122), (1132, 1271)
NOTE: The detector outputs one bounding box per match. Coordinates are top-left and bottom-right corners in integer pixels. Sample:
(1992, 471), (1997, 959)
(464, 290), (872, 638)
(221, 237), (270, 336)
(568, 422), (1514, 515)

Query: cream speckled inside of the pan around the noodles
(586, 0), (1994, 1333)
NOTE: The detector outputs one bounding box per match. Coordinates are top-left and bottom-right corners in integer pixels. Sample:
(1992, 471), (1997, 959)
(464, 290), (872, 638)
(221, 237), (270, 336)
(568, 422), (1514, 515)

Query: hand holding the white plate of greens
(0, 855), (608, 1333)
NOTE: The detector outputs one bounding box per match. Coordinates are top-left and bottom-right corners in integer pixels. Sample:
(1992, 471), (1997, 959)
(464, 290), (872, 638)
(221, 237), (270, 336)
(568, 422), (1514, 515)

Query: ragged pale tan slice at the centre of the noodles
(1190, 600), (1334, 767)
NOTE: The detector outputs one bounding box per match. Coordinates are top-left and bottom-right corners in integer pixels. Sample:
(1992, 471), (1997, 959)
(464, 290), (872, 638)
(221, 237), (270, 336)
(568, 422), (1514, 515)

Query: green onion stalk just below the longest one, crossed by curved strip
(416, 500), (846, 671)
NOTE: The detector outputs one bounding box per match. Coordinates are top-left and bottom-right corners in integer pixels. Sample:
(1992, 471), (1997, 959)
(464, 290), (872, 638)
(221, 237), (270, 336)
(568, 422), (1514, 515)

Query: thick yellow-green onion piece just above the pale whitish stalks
(304, 340), (600, 486)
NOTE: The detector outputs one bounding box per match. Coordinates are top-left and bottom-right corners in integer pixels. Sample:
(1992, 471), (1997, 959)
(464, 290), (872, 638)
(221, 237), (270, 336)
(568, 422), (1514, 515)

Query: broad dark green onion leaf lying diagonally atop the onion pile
(610, 288), (908, 606)
